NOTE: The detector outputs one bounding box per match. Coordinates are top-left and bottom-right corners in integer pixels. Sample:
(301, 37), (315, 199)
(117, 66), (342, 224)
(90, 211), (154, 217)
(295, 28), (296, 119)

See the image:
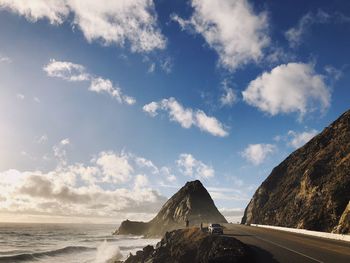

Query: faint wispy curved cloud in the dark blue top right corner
(285, 9), (350, 47)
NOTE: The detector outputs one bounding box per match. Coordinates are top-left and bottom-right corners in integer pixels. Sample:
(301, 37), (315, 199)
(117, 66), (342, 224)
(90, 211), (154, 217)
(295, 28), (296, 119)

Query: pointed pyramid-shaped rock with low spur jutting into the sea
(116, 180), (227, 236)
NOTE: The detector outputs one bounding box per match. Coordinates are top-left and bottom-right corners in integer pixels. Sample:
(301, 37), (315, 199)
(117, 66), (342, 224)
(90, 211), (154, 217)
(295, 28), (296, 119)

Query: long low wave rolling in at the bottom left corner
(0, 246), (96, 262)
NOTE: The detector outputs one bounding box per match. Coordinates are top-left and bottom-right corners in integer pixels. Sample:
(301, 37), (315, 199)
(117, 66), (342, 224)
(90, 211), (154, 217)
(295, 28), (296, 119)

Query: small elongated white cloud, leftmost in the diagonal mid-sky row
(43, 59), (90, 81)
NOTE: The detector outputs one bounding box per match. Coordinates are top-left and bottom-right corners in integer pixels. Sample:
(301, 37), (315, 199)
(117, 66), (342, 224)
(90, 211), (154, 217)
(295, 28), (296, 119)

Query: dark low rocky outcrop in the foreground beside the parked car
(124, 227), (252, 263)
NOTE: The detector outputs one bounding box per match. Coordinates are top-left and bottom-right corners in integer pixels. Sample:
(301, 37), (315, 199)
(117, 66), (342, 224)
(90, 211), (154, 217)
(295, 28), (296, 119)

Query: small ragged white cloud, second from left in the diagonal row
(89, 77), (136, 105)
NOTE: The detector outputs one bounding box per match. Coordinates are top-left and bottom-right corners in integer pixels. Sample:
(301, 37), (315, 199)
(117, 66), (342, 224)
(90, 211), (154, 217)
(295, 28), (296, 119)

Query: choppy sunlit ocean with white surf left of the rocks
(0, 223), (159, 263)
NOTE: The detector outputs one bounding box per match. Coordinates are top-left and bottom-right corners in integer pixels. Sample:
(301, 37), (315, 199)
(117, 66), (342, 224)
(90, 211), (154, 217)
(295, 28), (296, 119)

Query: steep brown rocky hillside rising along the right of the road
(242, 111), (350, 233)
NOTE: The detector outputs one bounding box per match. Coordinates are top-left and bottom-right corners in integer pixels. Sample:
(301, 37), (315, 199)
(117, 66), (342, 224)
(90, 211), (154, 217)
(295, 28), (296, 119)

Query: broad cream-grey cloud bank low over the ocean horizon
(0, 150), (178, 220)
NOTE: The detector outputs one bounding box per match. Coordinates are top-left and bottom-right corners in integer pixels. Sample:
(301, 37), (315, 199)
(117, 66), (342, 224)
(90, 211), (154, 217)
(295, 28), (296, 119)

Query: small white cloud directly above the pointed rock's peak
(176, 153), (215, 179)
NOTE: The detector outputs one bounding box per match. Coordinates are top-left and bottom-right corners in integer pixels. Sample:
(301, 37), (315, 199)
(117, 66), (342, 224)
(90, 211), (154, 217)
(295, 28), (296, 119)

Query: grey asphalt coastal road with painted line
(224, 224), (350, 263)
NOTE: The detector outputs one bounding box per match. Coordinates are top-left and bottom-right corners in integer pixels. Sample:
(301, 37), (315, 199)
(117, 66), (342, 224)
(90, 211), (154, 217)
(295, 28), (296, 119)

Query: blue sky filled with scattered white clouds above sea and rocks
(0, 0), (350, 224)
